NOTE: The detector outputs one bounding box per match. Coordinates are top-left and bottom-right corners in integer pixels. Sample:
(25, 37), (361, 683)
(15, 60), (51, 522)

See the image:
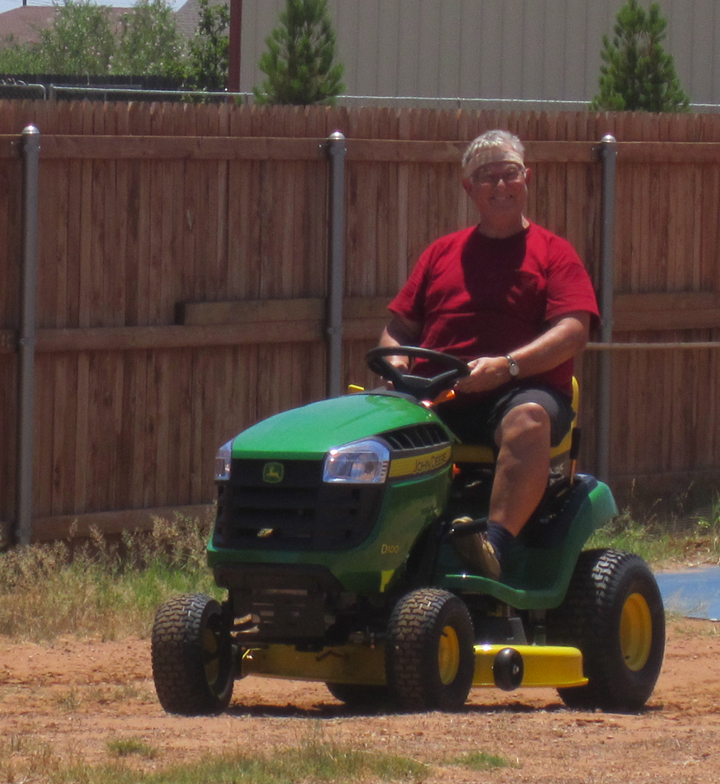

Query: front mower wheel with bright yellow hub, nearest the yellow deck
(385, 588), (475, 711)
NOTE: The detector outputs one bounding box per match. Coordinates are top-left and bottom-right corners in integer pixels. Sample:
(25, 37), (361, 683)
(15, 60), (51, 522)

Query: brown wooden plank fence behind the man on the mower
(0, 102), (720, 540)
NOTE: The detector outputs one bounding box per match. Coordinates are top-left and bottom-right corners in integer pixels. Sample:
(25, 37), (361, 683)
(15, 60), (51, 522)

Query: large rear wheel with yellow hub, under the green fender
(548, 550), (665, 712)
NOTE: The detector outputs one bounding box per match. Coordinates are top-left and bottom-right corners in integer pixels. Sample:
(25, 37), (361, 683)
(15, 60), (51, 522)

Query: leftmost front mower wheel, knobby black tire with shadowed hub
(152, 594), (234, 716)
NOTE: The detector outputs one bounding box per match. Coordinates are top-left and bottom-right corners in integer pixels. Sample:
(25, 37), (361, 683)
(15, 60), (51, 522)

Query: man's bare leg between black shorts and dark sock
(489, 403), (550, 536)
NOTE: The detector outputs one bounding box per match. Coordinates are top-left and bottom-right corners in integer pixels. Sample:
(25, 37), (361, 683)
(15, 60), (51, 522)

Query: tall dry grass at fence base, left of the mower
(0, 517), (219, 642)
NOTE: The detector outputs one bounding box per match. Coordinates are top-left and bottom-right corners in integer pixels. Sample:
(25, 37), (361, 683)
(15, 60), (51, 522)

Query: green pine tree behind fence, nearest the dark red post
(254, 0), (345, 106)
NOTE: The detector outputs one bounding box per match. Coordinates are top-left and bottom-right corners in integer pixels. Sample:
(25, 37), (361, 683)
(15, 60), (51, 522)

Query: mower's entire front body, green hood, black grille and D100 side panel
(208, 393), (451, 594)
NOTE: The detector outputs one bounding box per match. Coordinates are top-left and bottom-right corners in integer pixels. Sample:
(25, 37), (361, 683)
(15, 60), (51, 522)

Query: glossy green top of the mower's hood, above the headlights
(232, 394), (439, 460)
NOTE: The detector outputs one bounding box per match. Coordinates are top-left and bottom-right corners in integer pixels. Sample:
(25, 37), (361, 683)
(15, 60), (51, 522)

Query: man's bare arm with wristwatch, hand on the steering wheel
(455, 310), (591, 392)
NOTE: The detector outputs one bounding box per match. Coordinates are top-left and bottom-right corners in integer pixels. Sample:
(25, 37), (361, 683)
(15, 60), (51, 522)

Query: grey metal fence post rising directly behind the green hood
(326, 131), (346, 397)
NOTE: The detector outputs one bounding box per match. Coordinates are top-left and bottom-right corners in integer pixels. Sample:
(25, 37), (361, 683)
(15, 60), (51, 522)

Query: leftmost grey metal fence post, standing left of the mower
(16, 125), (40, 544)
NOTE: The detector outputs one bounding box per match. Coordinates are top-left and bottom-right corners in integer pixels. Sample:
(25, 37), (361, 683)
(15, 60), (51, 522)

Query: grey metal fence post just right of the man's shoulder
(596, 134), (617, 481)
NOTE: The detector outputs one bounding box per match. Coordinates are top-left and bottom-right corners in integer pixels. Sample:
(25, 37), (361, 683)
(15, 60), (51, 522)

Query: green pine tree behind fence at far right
(590, 0), (690, 112)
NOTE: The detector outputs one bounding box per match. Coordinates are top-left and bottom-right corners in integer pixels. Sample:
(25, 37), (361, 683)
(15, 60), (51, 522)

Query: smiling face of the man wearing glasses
(463, 155), (530, 220)
